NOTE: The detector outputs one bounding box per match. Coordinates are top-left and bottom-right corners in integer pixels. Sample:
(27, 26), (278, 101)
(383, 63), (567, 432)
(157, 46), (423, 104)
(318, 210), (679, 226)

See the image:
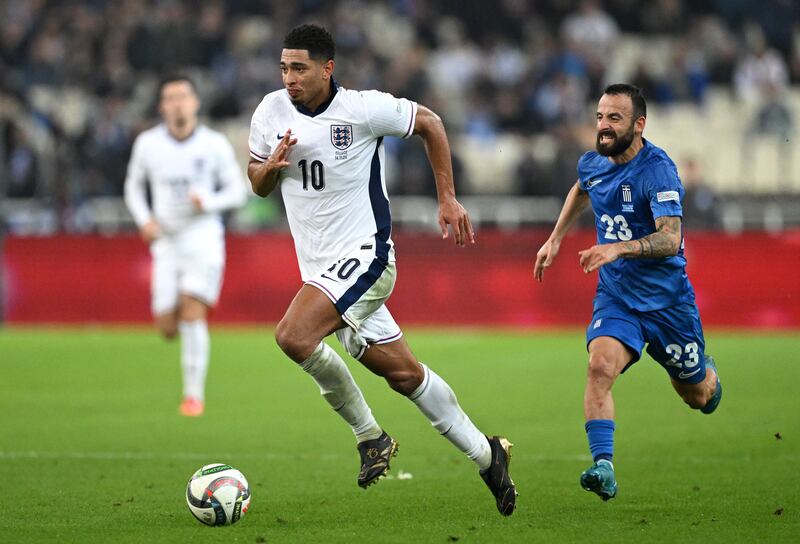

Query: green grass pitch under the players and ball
(0, 328), (800, 543)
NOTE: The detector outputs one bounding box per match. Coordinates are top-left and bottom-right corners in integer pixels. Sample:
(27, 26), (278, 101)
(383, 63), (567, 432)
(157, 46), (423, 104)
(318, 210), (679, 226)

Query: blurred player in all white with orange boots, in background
(125, 76), (247, 416)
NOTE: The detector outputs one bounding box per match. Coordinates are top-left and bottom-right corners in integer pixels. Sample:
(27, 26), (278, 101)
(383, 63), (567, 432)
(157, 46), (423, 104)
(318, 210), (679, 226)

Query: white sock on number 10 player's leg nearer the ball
(300, 342), (383, 442)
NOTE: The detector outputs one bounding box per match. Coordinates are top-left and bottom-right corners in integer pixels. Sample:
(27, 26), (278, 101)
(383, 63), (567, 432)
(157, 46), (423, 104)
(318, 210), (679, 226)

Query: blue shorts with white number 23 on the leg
(586, 295), (706, 383)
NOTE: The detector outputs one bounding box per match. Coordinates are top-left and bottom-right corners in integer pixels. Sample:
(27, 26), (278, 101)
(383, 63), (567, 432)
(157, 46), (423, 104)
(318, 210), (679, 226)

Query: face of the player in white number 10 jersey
(281, 49), (333, 109)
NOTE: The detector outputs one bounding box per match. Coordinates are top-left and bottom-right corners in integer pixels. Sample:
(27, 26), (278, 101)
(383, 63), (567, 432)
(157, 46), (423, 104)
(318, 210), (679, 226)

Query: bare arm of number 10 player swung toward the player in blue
(414, 105), (475, 247)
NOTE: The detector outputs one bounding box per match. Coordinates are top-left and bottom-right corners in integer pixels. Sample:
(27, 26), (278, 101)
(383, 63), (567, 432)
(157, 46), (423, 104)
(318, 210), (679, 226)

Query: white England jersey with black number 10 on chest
(249, 86), (417, 281)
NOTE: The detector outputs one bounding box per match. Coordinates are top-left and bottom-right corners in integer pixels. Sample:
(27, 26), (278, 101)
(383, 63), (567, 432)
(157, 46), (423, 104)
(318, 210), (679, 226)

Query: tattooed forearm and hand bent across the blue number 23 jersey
(579, 216), (681, 273)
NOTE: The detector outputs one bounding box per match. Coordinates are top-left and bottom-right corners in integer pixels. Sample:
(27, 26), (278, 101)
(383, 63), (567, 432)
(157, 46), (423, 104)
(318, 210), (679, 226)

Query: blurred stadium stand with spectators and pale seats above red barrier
(0, 0), (800, 234)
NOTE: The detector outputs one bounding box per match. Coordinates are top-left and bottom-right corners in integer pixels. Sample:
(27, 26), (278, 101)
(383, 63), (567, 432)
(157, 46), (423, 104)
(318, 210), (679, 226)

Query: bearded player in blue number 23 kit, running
(534, 84), (722, 500)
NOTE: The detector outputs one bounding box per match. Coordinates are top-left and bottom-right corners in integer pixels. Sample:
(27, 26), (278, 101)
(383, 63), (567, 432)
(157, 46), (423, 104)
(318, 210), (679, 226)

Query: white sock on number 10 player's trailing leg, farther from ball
(408, 363), (492, 470)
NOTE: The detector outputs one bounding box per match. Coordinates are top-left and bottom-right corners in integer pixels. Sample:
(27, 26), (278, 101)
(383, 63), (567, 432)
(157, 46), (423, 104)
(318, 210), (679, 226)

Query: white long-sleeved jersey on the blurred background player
(125, 124), (247, 235)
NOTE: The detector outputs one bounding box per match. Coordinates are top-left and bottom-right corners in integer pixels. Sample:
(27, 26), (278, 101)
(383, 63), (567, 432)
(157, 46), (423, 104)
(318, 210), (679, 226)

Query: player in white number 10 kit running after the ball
(247, 25), (516, 516)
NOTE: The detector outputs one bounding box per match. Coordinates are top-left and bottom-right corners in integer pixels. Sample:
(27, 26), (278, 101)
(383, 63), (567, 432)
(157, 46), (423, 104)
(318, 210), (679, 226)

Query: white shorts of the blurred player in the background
(150, 229), (225, 315)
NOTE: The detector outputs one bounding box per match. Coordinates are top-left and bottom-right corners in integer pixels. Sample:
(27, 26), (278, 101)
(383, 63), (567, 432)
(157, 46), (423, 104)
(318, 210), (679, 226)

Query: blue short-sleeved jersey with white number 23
(578, 140), (694, 311)
